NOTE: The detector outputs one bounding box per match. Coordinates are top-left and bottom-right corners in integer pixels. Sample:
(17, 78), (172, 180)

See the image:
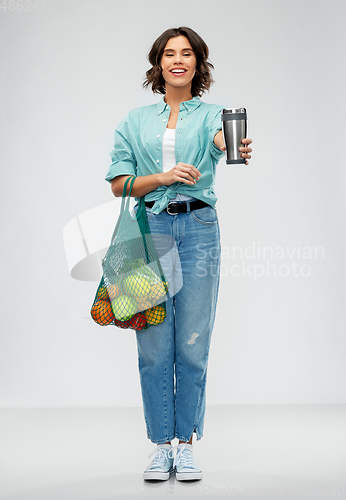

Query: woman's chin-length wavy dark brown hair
(143, 26), (214, 97)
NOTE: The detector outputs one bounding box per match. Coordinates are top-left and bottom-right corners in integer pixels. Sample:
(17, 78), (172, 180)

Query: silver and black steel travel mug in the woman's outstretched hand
(221, 108), (247, 165)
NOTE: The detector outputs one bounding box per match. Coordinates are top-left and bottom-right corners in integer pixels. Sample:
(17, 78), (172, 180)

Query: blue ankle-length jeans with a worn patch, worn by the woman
(135, 204), (221, 443)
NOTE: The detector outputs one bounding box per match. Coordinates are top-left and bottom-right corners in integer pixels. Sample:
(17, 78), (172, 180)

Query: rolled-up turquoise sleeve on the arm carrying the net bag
(105, 116), (137, 182)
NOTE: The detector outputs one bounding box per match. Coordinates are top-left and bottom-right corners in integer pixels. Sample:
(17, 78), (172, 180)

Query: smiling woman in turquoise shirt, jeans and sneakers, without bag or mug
(106, 27), (252, 480)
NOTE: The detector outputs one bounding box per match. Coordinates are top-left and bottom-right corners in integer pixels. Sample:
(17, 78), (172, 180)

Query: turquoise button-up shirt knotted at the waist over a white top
(106, 96), (225, 214)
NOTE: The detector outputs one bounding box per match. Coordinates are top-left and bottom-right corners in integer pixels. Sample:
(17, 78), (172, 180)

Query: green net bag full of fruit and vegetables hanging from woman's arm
(91, 177), (169, 331)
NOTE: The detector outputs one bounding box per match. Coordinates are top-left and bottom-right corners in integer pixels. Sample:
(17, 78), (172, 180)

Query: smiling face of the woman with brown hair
(161, 35), (196, 92)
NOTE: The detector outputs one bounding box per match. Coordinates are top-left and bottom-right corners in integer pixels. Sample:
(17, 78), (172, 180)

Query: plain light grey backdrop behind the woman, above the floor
(0, 0), (346, 406)
